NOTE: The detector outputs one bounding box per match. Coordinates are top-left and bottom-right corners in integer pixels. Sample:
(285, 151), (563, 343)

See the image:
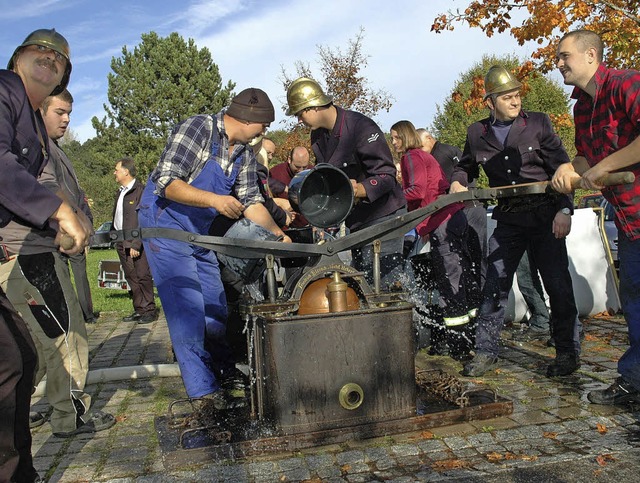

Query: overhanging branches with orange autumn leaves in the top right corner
(431, 0), (640, 72)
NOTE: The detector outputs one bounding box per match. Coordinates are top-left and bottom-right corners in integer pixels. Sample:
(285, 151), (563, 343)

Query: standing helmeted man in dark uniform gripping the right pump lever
(450, 65), (580, 377)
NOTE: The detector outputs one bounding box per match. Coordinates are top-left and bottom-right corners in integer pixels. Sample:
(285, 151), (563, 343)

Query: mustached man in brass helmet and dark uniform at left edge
(0, 29), (90, 482)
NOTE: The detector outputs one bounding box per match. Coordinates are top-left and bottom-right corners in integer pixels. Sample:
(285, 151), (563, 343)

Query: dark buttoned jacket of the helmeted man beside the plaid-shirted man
(451, 111), (573, 224)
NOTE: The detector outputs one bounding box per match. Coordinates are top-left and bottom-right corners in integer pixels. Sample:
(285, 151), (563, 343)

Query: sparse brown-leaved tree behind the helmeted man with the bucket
(281, 27), (393, 157)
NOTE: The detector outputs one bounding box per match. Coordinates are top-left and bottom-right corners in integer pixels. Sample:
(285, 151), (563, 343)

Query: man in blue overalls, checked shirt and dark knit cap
(138, 88), (291, 410)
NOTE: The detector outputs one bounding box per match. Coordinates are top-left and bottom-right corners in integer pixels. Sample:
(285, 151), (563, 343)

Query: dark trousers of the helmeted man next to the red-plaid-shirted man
(476, 220), (578, 356)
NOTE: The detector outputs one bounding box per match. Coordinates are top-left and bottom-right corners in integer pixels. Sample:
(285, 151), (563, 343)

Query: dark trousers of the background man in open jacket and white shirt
(116, 243), (156, 315)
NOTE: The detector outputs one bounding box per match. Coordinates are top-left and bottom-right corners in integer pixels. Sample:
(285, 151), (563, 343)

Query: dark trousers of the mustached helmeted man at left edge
(0, 290), (38, 483)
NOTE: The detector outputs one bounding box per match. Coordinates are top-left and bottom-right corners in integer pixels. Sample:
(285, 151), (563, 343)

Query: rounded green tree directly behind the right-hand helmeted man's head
(431, 56), (575, 186)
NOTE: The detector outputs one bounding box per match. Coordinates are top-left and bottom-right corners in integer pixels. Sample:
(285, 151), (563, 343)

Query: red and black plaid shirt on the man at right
(571, 64), (640, 240)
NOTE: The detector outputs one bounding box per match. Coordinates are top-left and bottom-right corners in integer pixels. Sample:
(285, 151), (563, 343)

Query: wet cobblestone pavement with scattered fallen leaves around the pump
(33, 314), (640, 483)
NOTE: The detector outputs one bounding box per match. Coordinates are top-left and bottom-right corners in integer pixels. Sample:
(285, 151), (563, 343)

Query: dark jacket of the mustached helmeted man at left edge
(0, 70), (62, 231)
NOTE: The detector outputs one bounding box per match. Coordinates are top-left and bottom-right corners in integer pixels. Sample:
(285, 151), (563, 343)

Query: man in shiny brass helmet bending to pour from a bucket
(286, 77), (407, 285)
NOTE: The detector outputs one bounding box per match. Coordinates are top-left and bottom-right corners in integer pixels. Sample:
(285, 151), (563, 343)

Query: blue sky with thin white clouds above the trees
(0, 0), (560, 141)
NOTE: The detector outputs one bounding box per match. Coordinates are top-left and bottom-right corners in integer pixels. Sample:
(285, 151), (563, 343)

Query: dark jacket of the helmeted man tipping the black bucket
(311, 106), (406, 231)
